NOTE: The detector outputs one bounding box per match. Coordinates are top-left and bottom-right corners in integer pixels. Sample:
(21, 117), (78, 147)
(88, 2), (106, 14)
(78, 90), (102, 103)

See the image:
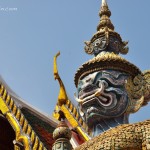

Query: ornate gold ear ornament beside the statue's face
(126, 71), (150, 113)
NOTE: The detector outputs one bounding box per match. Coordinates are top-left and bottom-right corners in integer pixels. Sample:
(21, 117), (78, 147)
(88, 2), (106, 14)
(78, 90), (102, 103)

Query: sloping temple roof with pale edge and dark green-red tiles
(0, 76), (59, 149)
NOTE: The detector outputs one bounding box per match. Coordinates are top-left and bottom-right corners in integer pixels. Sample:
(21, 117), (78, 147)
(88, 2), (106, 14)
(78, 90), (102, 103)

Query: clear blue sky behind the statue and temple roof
(0, 0), (150, 122)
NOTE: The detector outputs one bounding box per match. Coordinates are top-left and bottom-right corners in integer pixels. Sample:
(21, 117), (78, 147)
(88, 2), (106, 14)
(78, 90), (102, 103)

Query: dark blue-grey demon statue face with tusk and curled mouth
(77, 70), (129, 126)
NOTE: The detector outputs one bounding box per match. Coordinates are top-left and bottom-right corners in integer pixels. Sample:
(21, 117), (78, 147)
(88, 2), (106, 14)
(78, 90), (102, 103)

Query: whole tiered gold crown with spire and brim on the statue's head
(75, 0), (141, 86)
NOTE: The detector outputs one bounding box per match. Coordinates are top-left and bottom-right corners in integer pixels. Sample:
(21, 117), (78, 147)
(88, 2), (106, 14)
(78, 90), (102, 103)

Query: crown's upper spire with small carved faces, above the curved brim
(84, 0), (128, 56)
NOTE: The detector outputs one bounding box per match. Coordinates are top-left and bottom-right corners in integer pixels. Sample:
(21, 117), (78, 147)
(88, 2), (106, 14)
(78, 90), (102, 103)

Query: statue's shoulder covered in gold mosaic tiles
(75, 120), (150, 150)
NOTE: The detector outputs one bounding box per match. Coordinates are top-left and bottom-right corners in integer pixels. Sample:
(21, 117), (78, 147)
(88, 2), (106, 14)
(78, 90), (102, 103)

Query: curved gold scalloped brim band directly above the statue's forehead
(74, 52), (141, 86)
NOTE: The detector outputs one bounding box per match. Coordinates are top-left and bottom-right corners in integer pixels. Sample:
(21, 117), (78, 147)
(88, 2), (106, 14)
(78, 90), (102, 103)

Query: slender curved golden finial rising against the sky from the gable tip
(54, 52), (68, 105)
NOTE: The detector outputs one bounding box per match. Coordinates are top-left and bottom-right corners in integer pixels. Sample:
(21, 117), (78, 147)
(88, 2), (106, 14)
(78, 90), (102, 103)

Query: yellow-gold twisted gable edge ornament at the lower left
(0, 83), (46, 150)
